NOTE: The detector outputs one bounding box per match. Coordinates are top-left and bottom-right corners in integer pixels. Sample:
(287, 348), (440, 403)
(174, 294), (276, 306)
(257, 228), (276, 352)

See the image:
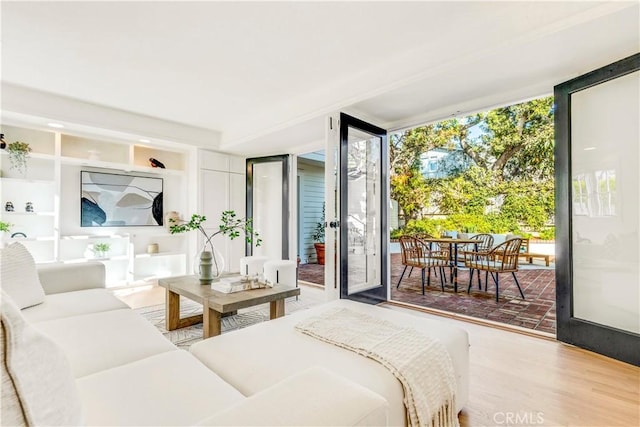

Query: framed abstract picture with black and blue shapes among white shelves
(80, 171), (163, 227)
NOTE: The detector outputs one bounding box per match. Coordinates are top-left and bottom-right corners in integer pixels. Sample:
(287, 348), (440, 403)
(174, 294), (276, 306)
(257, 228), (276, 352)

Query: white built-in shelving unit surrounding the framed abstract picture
(0, 125), (195, 287)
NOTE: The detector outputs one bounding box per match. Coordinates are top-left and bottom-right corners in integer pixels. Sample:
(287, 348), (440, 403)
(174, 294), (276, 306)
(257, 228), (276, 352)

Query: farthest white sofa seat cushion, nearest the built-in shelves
(22, 289), (129, 322)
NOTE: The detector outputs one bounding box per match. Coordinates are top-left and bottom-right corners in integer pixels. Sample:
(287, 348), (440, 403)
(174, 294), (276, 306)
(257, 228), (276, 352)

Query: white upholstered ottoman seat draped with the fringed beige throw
(190, 300), (469, 425)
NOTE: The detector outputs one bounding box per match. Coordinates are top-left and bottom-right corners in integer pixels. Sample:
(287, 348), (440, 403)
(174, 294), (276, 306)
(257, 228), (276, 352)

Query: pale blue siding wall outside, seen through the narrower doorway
(298, 159), (324, 263)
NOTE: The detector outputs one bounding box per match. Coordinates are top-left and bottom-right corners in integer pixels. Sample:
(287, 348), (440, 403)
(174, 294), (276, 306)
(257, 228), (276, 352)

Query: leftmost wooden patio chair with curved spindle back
(396, 236), (449, 295)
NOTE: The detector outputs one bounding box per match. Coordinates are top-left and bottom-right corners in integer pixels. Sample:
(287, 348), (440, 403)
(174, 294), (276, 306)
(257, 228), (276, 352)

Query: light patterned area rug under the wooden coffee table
(136, 286), (325, 350)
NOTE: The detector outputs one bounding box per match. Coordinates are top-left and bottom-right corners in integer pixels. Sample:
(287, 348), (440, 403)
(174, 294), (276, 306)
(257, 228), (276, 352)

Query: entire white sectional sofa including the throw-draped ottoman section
(0, 245), (468, 426)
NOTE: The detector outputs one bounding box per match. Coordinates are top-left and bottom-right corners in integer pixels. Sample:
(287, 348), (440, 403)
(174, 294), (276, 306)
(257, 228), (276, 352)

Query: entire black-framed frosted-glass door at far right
(555, 54), (640, 365)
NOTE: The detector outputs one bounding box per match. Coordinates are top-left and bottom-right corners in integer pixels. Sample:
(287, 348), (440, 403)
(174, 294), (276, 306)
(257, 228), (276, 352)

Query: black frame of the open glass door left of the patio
(338, 113), (389, 304)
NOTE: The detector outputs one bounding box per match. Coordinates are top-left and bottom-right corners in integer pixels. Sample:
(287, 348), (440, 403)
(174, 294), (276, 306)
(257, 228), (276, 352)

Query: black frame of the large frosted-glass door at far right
(554, 54), (640, 366)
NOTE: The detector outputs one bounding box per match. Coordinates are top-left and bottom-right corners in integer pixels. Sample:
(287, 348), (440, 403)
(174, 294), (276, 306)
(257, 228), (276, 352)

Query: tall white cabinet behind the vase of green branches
(198, 150), (246, 272)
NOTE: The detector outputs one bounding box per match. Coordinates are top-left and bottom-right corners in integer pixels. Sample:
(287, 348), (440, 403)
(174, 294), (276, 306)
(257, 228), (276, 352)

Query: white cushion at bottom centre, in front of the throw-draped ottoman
(198, 367), (389, 426)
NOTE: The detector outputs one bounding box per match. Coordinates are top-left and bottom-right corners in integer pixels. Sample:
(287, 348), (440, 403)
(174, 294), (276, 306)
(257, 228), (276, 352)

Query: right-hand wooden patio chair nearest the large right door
(464, 238), (525, 302)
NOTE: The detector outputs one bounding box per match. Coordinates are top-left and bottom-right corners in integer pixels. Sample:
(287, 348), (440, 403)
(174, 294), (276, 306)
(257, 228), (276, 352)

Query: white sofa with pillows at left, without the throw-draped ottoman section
(0, 244), (388, 426)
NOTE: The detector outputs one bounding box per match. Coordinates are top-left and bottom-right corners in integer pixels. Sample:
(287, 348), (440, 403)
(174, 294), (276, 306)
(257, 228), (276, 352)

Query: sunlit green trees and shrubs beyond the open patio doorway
(391, 97), (556, 239)
